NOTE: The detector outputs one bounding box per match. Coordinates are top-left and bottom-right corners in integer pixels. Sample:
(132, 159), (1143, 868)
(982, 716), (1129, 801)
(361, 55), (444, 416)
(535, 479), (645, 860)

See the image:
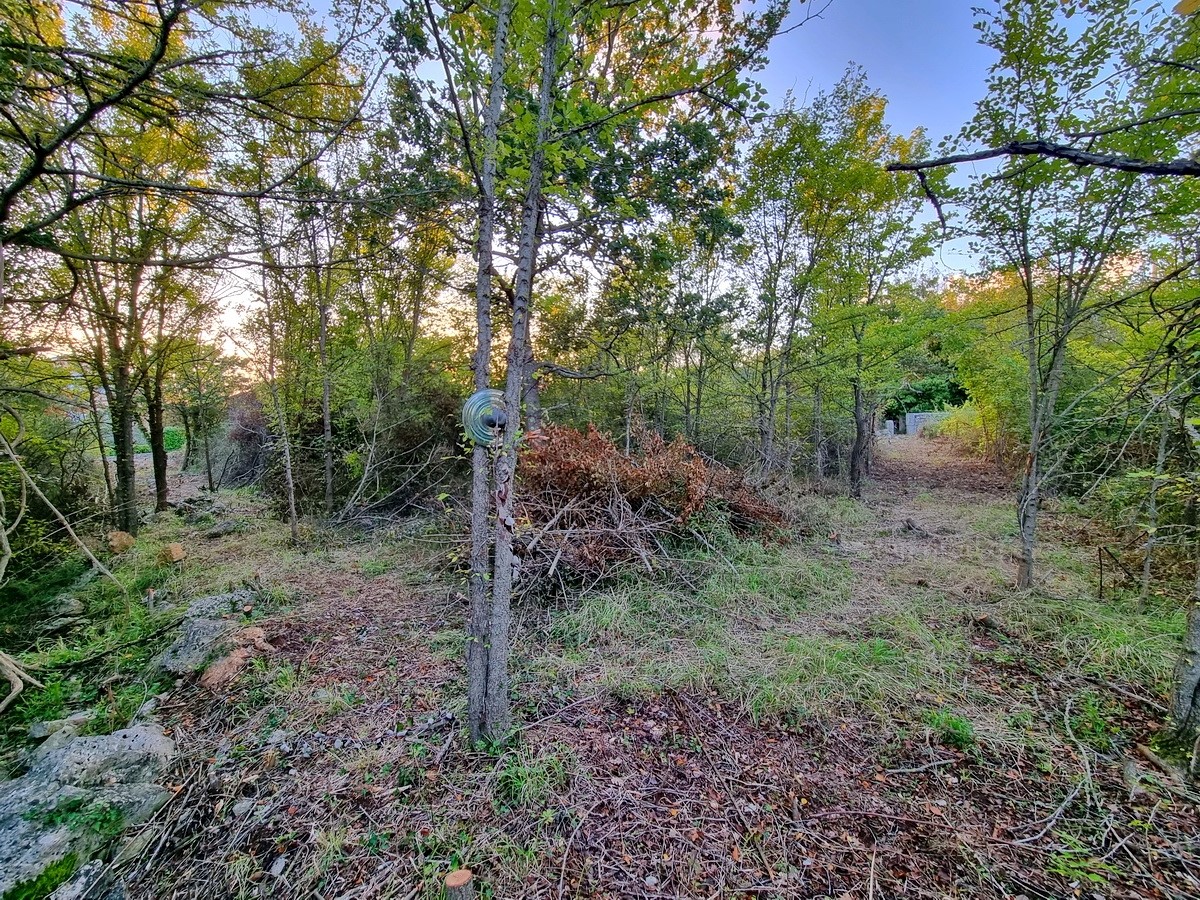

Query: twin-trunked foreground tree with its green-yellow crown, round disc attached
(403, 0), (781, 739)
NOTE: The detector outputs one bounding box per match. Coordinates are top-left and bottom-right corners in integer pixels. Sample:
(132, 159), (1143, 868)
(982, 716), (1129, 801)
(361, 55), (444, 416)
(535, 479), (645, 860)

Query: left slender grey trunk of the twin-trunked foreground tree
(460, 0), (518, 742)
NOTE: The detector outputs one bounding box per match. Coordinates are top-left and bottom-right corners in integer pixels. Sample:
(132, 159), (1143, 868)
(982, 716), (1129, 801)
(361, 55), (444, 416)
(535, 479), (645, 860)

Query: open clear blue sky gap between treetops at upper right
(757, 0), (995, 271)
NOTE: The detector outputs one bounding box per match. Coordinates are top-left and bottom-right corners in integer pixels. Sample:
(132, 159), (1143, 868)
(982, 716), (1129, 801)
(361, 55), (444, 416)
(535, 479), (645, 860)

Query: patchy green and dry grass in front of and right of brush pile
(526, 465), (1183, 763)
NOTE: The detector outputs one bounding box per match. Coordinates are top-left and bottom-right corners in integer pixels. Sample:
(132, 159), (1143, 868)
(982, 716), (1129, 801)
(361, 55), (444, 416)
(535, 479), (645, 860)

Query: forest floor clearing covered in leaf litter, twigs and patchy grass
(9, 438), (1200, 900)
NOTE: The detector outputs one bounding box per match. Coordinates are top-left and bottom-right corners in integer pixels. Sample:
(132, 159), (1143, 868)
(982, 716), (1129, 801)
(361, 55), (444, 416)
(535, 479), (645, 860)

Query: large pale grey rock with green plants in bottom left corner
(0, 726), (175, 898)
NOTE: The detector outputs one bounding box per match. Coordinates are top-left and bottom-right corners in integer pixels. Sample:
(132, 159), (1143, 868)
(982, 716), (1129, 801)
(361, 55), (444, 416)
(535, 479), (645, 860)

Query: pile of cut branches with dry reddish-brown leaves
(516, 425), (784, 594)
